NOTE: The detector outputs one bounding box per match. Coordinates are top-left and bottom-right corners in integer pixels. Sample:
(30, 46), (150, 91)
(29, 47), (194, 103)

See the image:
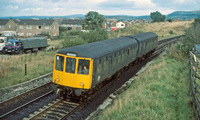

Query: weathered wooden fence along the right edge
(190, 52), (200, 120)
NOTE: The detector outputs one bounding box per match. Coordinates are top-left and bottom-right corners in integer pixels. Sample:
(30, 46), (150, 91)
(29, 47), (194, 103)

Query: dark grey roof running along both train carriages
(57, 33), (156, 58)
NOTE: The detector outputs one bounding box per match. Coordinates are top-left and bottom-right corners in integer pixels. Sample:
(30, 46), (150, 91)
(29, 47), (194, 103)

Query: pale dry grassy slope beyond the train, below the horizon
(109, 21), (192, 39)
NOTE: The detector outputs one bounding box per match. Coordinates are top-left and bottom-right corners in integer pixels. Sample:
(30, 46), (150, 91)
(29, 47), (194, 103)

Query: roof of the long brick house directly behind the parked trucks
(17, 19), (54, 25)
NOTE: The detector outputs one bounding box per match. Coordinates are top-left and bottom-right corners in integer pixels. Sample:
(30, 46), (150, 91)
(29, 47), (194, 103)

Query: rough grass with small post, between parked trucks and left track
(0, 51), (55, 88)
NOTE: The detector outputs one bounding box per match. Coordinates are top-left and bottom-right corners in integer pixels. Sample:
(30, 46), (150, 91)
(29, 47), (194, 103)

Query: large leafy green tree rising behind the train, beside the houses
(82, 11), (104, 30)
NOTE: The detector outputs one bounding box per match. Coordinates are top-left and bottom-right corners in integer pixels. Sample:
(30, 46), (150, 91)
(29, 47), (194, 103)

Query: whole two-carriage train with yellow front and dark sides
(53, 32), (158, 96)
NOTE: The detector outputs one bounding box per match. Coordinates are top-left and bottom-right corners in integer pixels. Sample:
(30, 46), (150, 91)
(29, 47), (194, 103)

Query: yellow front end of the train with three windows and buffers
(53, 54), (93, 97)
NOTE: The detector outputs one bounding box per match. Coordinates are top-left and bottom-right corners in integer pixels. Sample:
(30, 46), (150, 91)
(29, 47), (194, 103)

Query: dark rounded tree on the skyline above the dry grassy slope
(150, 11), (165, 22)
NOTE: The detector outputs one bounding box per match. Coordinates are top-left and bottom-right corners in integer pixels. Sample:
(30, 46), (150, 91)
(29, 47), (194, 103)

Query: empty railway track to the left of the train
(0, 83), (54, 120)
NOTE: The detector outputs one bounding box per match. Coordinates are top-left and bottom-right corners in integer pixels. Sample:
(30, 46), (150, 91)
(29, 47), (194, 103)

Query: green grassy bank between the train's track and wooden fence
(98, 48), (194, 120)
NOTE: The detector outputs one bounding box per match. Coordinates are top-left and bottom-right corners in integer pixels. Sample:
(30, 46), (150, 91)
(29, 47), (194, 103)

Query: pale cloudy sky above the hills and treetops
(0, 0), (200, 17)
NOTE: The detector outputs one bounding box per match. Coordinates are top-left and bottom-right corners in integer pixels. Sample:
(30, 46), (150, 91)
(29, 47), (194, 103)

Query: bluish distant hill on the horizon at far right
(166, 11), (200, 20)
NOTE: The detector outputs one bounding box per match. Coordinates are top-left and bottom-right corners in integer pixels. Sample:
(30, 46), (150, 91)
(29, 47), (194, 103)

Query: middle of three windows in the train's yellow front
(65, 57), (76, 73)
